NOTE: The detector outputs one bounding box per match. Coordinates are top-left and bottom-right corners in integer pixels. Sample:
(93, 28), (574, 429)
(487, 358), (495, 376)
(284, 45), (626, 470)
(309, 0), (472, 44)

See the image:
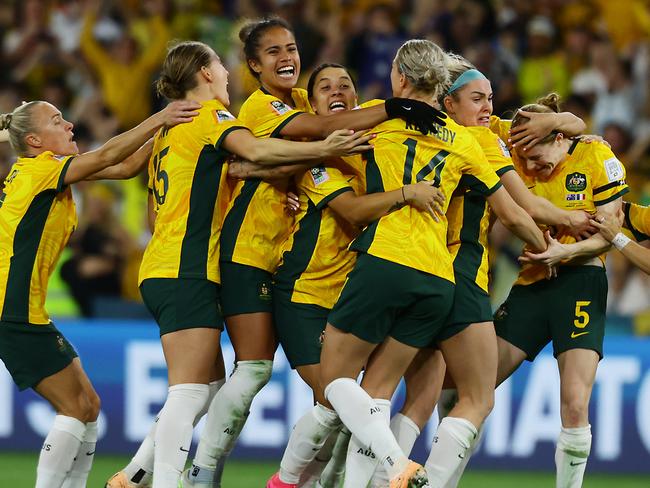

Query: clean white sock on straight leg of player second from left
(153, 383), (209, 488)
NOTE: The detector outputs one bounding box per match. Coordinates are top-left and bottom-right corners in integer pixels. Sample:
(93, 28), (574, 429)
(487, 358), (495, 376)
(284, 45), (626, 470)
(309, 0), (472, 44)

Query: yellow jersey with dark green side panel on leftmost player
(0, 151), (77, 325)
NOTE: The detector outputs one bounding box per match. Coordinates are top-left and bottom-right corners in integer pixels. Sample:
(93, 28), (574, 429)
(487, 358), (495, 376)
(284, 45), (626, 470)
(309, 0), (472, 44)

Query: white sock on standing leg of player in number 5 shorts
(555, 425), (591, 488)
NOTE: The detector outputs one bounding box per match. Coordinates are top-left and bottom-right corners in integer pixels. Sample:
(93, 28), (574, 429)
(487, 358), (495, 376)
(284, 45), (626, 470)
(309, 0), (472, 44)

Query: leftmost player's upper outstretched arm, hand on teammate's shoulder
(65, 100), (201, 185)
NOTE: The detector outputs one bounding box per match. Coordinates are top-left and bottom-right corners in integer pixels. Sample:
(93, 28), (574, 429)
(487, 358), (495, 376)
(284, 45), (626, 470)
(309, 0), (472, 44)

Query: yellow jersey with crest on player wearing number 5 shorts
(516, 140), (629, 285)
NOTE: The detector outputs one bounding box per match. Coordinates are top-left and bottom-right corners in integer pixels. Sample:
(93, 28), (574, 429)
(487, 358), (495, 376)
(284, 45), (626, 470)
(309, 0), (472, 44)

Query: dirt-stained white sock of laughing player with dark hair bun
(191, 360), (273, 476)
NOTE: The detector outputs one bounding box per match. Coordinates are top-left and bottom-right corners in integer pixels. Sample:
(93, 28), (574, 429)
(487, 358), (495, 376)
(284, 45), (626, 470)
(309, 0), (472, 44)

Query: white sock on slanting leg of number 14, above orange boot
(325, 378), (409, 479)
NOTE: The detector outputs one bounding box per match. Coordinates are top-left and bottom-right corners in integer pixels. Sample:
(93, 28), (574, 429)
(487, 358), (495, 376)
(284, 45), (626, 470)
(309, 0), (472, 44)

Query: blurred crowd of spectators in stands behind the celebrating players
(0, 0), (650, 333)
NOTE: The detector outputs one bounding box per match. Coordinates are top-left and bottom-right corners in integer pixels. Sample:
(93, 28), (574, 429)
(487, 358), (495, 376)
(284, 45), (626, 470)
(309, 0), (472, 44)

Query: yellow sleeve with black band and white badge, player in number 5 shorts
(590, 142), (630, 207)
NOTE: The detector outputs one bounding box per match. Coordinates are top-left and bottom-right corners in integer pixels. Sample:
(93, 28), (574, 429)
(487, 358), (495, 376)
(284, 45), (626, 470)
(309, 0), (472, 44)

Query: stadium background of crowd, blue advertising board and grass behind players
(0, 0), (650, 487)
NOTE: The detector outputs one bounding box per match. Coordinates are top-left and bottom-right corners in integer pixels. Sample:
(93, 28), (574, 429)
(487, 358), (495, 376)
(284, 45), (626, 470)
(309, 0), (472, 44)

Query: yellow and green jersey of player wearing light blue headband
(447, 127), (515, 292)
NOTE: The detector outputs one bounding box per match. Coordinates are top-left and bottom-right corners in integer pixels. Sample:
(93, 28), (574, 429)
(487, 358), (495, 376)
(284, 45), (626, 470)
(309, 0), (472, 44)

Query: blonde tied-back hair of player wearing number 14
(395, 39), (449, 99)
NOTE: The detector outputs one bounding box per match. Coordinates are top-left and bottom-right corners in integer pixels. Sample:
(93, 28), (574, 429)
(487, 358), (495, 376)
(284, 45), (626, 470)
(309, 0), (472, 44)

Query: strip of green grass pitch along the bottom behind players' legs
(0, 452), (650, 488)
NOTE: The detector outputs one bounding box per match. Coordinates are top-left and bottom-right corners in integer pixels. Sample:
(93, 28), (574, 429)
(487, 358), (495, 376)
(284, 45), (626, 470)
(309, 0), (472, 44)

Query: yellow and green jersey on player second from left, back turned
(139, 100), (245, 283)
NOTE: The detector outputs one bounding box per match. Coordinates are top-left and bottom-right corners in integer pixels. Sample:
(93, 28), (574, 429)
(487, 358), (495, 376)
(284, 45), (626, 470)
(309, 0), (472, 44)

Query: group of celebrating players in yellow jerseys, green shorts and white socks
(0, 13), (650, 488)
